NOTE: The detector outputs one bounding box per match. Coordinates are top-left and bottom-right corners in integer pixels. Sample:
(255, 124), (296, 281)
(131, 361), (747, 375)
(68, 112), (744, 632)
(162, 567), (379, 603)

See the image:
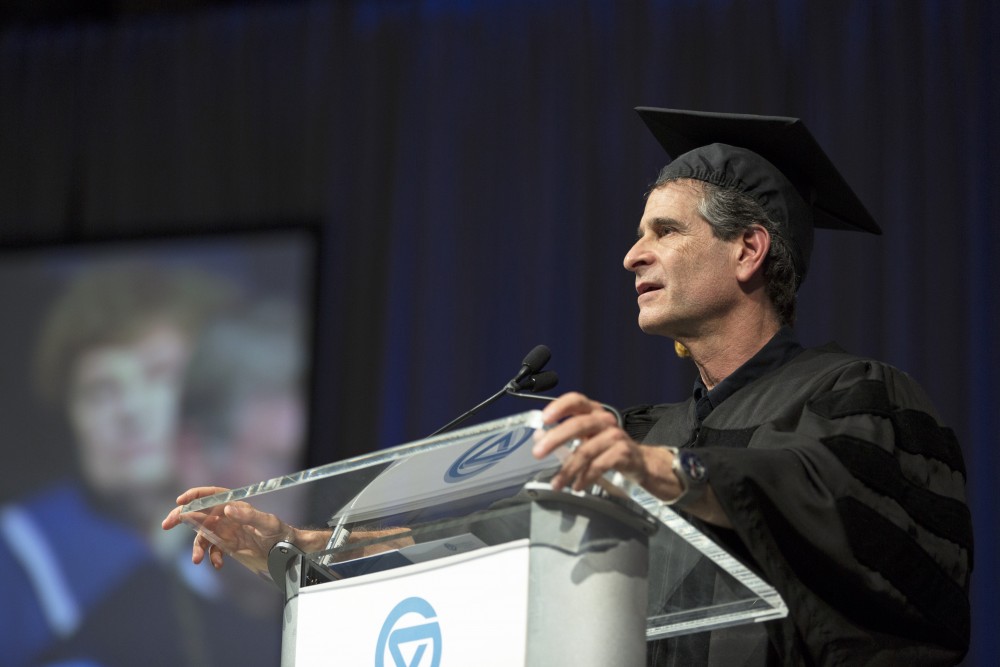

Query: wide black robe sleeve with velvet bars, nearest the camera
(701, 362), (972, 665)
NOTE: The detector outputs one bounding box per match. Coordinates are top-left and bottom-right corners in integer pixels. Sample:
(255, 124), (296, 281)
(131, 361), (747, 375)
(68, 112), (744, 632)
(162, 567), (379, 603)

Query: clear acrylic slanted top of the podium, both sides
(182, 411), (787, 639)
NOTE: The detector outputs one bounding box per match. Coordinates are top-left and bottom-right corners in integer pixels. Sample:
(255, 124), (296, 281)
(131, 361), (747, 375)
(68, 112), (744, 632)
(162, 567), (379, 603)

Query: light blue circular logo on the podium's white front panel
(375, 597), (441, 667)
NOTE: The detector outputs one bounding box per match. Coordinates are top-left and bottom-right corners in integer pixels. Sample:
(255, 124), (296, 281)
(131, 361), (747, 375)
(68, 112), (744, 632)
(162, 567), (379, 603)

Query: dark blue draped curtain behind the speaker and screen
(0, 0), (1000, 664)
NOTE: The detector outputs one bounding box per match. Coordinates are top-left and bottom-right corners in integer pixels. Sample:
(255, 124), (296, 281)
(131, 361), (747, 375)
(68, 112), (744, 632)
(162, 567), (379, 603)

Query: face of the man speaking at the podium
(625, 180), (740, 339)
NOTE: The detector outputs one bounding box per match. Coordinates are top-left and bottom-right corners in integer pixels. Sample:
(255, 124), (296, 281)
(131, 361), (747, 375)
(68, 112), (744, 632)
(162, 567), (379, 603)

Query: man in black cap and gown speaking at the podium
(535, 109), (972, 665)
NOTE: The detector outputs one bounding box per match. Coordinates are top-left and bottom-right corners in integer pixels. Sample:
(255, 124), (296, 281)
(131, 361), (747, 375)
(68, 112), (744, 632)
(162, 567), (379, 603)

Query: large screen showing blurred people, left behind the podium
(0, 230), (314, 667)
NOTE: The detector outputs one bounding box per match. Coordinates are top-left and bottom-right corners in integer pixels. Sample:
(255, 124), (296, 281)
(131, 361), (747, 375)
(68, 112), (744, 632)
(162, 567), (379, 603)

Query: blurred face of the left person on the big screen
(69, 323), (190, 493)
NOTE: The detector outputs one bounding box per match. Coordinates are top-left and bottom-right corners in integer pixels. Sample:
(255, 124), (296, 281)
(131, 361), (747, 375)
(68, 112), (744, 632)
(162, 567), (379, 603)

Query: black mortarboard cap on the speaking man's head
(636, 107), (882, 280)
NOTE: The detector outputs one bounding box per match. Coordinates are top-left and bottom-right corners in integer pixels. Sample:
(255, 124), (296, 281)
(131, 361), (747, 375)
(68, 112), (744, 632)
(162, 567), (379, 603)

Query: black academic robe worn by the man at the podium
(625, 347), (972, 665)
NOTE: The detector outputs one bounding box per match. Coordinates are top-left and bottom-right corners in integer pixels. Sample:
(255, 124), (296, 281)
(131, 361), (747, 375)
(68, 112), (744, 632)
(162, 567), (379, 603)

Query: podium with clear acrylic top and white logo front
(182, 411), (787, 667)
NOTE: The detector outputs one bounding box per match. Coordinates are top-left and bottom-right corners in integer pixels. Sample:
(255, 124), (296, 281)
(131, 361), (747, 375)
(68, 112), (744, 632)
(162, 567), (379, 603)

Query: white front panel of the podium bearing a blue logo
(295, 539), (529, 667)
